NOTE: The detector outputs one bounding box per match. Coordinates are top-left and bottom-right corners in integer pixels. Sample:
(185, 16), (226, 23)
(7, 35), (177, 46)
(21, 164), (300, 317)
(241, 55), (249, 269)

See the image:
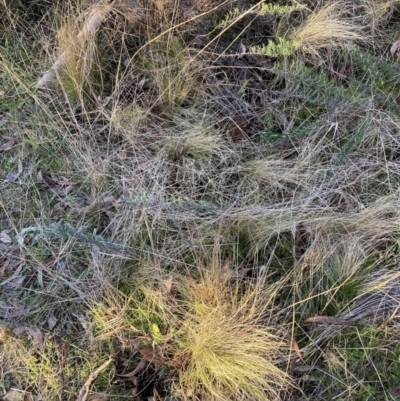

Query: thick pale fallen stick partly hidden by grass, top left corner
(35, 0), (116, 89)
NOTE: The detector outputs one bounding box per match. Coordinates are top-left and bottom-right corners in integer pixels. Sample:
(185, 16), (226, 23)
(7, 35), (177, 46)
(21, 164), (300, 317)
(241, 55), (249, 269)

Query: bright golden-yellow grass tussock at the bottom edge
(175, 270), (289, 400)
